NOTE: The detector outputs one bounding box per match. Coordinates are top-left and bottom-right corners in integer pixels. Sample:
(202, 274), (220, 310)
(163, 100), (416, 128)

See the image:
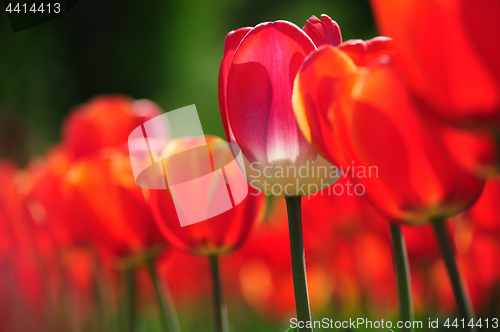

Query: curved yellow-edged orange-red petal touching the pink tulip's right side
(292, 46), (357, 165)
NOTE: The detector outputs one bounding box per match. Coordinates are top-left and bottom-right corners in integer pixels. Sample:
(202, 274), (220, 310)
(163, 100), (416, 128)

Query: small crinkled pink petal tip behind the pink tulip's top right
(302, 14), (342, 47)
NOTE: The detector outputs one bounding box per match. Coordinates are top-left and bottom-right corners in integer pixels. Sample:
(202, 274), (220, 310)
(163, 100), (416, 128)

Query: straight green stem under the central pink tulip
(285, 196), (312, 332)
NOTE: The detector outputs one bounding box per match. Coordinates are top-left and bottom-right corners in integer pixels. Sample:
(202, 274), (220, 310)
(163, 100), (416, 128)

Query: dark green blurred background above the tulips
(0, 0), (376, 167)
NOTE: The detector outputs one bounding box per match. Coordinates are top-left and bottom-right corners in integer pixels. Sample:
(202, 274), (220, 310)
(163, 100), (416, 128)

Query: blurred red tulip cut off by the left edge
(0, 162), (65, 331)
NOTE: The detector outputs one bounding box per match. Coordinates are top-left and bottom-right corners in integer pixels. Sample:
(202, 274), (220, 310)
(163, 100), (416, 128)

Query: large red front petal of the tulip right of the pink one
(335, 65), (484, 223)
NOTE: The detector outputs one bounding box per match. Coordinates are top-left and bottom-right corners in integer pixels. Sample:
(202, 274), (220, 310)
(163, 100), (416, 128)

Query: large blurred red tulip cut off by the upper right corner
(371, 0), (500, 128)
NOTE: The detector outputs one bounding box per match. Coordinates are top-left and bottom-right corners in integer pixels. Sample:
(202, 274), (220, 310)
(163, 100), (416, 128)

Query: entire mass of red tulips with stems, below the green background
(0, 0), (500, 332)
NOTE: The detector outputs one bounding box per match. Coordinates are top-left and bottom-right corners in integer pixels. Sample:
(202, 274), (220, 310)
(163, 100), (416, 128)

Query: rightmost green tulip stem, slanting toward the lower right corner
(433, 220), (474, 331)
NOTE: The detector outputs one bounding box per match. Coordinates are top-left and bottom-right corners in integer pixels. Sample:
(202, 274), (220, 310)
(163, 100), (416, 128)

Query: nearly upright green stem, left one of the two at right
(389, 223), (414, 332)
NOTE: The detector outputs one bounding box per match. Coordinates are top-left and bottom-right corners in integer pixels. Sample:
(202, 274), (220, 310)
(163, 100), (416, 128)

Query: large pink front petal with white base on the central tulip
(226, 21), (316, 164)
